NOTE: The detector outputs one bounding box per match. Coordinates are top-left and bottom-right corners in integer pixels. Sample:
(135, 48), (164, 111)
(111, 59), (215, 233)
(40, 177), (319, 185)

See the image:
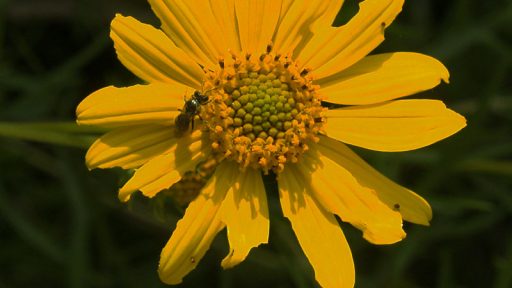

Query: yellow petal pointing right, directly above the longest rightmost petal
(317, 52), (449, 105)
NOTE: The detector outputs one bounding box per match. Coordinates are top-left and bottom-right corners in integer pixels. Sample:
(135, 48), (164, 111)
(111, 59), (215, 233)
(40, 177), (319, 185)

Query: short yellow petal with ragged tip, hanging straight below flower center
(220, 165), (269, 268)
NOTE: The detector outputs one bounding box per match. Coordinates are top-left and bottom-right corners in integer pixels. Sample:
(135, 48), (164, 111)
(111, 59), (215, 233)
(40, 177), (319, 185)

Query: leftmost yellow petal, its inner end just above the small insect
(76, 83), (185, 127)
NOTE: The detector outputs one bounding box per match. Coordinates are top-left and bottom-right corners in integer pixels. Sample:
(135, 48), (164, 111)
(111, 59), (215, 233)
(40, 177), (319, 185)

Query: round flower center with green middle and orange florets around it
(200, 45), (324, 173)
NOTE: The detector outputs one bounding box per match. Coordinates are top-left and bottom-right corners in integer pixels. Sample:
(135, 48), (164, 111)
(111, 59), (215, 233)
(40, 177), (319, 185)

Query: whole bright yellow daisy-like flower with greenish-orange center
(77, 0), (465, 287)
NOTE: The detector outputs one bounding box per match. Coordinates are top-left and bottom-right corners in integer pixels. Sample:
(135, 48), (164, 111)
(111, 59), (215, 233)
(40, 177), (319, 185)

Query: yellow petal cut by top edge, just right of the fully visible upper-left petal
(149, 0), (230, 69)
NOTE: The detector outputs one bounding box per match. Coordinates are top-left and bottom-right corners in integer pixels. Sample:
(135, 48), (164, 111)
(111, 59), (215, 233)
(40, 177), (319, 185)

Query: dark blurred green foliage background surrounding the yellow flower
(0, 0), (512, 288)
